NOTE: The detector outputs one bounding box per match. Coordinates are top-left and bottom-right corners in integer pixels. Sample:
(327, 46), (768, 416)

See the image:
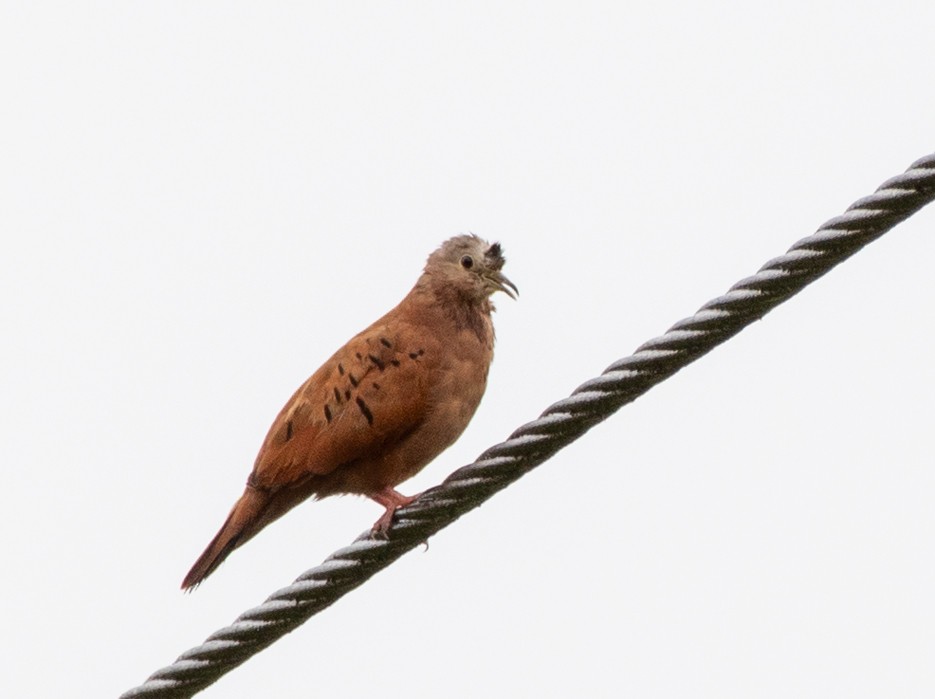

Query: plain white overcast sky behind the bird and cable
(0, 1), (935, 699)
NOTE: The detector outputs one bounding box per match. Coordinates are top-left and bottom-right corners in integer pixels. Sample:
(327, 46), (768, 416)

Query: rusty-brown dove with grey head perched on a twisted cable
(182, 234), (519, 591)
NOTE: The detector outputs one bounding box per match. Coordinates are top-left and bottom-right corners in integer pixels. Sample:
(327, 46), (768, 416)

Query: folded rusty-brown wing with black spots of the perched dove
(249, 319), (437, 492)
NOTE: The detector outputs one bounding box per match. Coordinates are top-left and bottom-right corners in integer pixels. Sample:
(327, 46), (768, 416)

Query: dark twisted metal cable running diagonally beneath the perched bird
(121, 154), (935, 699)
